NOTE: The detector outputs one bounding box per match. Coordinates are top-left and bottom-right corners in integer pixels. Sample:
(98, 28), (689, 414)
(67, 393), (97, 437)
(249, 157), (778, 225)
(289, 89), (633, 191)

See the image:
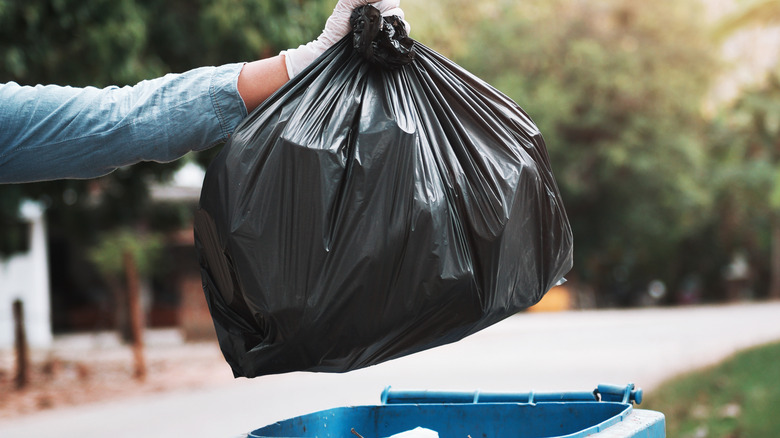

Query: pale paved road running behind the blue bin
(0, 302), (780, 438)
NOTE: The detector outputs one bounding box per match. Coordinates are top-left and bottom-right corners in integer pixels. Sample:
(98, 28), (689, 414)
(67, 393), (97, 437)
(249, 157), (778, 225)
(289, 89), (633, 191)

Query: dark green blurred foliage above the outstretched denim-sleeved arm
(0, 0), (332, 86)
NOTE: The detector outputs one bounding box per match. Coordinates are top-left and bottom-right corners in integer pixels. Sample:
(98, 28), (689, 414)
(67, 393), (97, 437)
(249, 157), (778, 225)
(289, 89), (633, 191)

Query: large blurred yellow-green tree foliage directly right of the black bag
(459, 0), (717, 302)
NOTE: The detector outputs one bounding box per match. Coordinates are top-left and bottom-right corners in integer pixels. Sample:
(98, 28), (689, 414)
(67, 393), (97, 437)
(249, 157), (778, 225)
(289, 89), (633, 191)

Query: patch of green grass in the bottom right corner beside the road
(640, 342), (780, 438)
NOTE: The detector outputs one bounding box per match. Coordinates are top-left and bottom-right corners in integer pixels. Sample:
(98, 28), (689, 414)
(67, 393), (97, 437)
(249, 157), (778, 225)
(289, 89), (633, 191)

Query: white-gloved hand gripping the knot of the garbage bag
(280, 0), (410, 79)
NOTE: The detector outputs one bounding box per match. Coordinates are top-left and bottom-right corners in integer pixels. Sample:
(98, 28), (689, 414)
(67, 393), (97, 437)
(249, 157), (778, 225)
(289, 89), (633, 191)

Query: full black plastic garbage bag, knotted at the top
(195, 6), (572, 377)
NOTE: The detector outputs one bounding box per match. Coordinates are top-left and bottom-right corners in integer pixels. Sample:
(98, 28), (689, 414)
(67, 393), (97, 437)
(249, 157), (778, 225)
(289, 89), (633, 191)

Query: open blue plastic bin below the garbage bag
(248, 385), (665, 438)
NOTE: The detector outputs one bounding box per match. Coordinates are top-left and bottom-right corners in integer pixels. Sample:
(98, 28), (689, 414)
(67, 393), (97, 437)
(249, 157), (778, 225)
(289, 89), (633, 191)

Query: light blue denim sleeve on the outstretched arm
(0, 64), (247, 183)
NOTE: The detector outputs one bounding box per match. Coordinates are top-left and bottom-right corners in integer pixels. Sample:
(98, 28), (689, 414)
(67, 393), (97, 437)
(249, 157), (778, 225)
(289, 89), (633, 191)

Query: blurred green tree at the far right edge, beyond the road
(713, 70), (780, 298)
